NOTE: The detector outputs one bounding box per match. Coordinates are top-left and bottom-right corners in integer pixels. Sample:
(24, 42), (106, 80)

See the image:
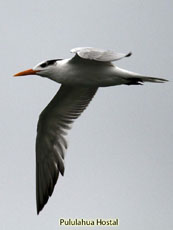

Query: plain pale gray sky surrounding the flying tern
(0, 0), (173, 230)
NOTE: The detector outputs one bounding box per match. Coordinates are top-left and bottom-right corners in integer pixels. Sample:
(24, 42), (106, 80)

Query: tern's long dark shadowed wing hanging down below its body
(36, 85), (97, 214)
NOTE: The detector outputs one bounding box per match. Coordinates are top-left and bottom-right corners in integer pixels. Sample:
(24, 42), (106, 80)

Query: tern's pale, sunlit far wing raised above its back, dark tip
(71, 47), (132, 62)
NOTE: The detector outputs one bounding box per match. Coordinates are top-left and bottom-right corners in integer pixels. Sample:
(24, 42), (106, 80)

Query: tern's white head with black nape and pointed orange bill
(14, 59), (61, 77)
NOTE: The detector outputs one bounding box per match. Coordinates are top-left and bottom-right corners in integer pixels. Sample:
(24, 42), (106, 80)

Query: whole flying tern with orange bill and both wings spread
(14, 47), (167, 214)
